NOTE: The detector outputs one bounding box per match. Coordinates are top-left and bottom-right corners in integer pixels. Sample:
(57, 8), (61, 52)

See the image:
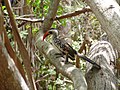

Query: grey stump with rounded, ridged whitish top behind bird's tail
(86, 41), (118, 90)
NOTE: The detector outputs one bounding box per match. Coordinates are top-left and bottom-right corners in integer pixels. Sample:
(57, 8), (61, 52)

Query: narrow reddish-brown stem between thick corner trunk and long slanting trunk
(0, 6), (26, 81)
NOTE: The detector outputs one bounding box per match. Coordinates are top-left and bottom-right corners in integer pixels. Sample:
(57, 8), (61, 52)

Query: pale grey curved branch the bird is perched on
(36, 38), (87, 90)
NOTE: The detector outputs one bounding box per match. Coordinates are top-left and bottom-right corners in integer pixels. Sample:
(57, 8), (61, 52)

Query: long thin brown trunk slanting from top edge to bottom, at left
(4, 0), (36, 90)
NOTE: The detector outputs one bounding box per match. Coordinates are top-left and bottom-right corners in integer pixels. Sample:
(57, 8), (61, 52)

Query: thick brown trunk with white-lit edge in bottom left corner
(0, 37), (29, 90)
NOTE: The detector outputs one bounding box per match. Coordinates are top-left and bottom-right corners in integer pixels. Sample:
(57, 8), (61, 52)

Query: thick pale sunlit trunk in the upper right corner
(85, 0), (120, 55)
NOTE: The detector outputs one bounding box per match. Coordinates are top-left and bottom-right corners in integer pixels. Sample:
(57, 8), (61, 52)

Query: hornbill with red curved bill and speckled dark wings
(43, 29), (100, 69)
